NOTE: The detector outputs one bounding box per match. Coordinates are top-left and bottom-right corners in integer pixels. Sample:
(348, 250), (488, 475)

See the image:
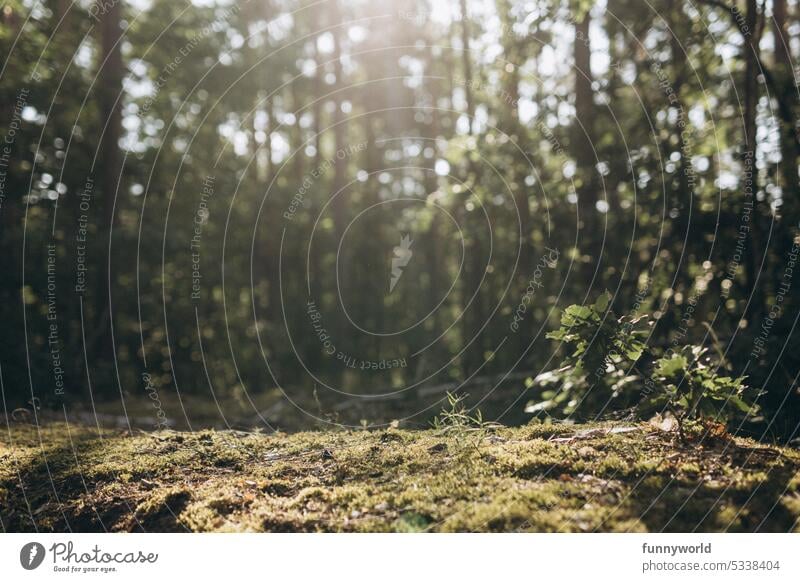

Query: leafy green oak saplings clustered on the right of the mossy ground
(525, 293), (757, 436)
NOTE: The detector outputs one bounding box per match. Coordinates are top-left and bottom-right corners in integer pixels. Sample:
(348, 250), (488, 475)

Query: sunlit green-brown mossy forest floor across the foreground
(0, 424), (800, 532)
